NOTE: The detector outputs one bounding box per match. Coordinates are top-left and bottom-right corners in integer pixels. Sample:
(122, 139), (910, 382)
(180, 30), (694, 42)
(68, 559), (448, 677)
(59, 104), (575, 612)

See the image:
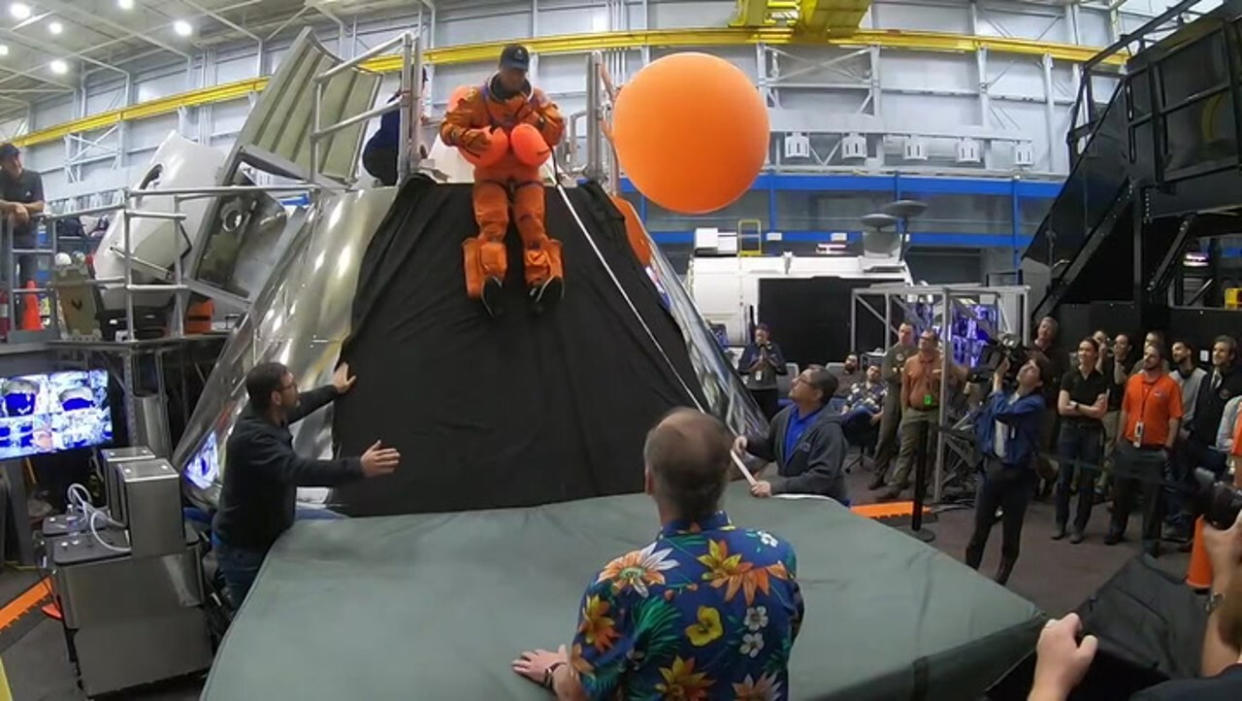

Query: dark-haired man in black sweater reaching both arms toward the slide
(212, 363), (401, 607)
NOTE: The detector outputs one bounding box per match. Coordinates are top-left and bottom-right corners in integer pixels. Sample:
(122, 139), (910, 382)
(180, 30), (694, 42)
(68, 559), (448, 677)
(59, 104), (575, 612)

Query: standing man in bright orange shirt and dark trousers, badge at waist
(1104, 344), (1182, 557)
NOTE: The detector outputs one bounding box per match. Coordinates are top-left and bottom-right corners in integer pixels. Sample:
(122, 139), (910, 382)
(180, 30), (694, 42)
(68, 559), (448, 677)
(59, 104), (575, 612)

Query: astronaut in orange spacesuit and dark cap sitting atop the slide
(440, 45), (565, 317)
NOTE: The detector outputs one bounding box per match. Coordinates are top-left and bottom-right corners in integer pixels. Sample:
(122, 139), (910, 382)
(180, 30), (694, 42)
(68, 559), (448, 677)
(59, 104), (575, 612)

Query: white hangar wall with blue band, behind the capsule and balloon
(0, 0), (1182, 282)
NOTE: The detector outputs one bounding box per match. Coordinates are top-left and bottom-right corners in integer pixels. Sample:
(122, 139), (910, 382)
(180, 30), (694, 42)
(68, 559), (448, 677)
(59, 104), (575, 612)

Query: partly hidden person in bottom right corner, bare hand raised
(1027, 512), (1242, 701)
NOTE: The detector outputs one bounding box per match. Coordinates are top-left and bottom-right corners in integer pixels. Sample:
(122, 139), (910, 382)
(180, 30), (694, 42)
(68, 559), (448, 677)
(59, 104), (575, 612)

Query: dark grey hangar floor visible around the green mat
(0, 464), (1189, 701)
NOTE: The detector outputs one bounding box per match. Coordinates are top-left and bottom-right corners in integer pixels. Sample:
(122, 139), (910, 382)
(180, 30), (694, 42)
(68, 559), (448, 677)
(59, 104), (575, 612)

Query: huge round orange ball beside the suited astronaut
(612, 52), (769, 214)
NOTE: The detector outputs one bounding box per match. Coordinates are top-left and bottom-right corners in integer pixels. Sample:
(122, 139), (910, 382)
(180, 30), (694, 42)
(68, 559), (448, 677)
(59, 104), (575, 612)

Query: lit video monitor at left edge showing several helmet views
(0, 370), (112, 460)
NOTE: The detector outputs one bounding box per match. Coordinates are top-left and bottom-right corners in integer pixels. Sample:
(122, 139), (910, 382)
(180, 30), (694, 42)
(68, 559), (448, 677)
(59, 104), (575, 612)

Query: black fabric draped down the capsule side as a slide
(332, 179), (702, 516)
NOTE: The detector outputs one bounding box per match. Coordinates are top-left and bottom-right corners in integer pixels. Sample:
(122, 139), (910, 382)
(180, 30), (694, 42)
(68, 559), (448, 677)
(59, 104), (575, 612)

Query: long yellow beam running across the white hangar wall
(14, 27), (1128, 148)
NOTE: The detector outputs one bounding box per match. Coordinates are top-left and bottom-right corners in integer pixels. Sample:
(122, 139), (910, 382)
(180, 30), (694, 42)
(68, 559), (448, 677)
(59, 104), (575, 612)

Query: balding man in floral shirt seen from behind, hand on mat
(513, 409), (802, 700)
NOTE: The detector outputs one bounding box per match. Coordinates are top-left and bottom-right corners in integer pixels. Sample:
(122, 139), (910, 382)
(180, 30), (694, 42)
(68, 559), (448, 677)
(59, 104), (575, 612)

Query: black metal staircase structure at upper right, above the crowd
(1022, 0), (1242, 321)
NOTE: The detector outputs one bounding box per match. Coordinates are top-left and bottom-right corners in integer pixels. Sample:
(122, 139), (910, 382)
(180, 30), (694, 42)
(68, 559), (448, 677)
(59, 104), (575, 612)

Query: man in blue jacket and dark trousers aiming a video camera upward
(966, 358), (1045, 584)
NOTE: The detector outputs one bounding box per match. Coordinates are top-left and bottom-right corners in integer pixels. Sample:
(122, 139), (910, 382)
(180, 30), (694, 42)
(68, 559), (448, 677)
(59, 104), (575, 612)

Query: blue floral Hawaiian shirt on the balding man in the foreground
(570, 511), (802, 701)
